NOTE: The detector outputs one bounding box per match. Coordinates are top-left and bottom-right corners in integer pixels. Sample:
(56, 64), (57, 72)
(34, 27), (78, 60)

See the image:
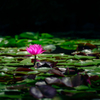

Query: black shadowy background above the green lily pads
(0, 0), (100, 36)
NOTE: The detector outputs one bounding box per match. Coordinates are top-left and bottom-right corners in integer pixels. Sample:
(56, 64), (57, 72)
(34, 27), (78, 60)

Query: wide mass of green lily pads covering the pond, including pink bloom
(0, 32), (100, 100)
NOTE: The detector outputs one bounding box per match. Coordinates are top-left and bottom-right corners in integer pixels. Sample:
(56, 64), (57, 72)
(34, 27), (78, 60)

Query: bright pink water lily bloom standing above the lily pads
(26, 44), (45, 55)
